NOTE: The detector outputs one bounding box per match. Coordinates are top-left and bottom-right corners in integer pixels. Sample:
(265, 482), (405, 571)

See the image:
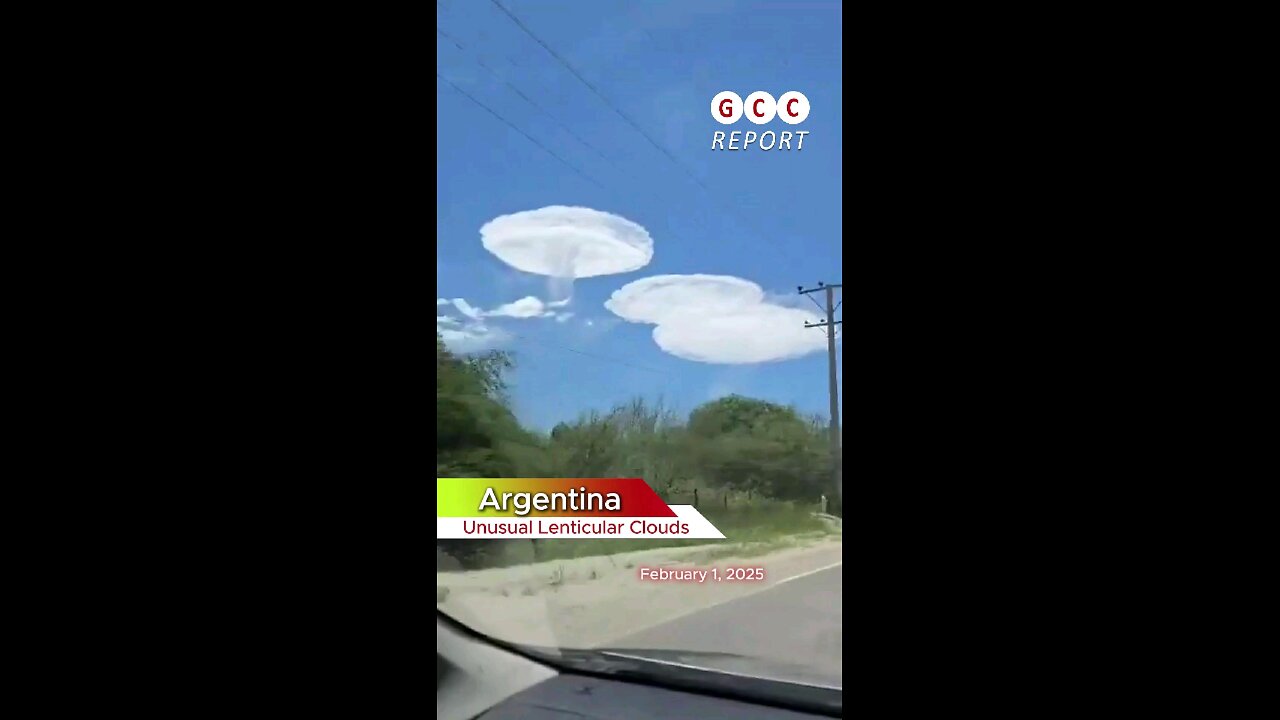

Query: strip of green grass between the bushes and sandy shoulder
(463, 502), (835, 568)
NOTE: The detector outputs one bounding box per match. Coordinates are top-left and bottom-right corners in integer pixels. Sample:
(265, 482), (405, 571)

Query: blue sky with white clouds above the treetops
(435, 0), (844, 429)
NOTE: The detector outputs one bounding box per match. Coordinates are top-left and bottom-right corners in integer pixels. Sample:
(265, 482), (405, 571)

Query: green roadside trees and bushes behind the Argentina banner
(435, 333), (840, 568)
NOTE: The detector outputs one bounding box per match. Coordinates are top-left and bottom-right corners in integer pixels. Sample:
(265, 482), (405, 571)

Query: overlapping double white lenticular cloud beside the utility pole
(604, 275), (827, 365)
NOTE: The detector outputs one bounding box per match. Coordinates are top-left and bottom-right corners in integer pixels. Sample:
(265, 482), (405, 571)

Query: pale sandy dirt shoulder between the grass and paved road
(435, 534), (844, 647)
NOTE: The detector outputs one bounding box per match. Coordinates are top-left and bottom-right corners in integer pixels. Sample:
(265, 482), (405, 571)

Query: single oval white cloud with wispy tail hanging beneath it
(480, 205), (653, 299)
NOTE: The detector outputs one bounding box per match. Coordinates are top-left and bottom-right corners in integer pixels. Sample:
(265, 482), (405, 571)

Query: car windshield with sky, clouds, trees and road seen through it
(435, 0), (844, 691)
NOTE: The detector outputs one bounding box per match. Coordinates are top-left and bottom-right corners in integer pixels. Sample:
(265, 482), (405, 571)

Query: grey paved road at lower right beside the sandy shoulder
(612, 565), (844, 687)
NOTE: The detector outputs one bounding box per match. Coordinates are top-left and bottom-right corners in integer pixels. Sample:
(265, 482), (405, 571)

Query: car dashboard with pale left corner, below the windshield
(435, 614), (841, 720)
